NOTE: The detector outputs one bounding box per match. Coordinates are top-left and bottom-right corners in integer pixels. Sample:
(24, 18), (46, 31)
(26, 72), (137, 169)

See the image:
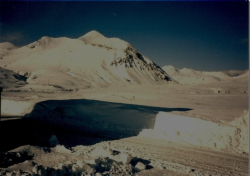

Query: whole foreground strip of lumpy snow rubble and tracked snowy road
(0, 137), (248, 176)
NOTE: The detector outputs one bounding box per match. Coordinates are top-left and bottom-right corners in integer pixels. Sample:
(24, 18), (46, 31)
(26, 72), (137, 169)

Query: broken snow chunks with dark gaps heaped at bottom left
(0, 143), (146, 176)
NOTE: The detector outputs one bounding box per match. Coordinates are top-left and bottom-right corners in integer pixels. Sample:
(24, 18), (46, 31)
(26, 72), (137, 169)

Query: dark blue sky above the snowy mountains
(0, 1), (249, 71)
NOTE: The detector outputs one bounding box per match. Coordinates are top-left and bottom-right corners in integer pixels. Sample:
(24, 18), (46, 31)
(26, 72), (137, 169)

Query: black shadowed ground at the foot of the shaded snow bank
(0, 119), (113, 152)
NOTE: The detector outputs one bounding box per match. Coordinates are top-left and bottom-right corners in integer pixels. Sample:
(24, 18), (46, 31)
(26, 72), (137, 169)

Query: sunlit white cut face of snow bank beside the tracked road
(139, 112), (249, 153)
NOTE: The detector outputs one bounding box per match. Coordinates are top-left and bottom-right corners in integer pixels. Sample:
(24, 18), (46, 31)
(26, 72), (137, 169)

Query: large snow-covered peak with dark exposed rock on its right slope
(0, 31), (174, 89)
